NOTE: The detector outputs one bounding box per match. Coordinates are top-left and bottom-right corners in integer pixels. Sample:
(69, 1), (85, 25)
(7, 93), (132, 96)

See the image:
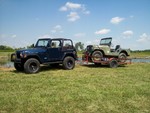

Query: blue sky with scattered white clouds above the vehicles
(0, 0), (150, 50)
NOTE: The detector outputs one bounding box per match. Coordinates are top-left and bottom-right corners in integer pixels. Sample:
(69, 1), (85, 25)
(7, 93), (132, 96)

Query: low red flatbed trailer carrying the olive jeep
(81, 54), (132, 68)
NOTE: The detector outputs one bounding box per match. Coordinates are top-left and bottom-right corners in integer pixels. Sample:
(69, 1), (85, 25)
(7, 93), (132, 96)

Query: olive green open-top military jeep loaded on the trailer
(83, 37), (130, 64)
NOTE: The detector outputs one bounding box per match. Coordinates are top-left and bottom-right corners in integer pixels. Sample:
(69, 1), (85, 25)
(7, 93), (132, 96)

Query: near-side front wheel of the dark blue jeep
(24, 58), (40, 74)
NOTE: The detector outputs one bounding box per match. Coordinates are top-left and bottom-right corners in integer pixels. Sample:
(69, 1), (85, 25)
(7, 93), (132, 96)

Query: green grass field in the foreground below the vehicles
(0, 63), (150, 113)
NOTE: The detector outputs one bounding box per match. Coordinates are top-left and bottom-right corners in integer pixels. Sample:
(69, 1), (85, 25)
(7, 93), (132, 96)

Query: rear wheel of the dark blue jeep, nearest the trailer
(63, 56), (75, 70)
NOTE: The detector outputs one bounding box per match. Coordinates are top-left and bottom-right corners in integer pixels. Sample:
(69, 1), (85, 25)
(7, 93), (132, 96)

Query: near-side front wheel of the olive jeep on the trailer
(92, 51), (103, 62)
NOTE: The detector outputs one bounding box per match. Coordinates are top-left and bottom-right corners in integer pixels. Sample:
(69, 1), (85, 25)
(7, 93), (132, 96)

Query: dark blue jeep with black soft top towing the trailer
(11, 38), (77, 73)
